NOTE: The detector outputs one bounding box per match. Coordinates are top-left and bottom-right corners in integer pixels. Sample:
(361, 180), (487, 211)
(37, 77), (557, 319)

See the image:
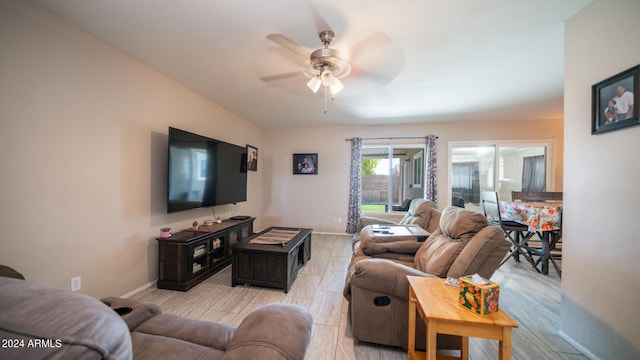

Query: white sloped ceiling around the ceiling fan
(34, 0), (590, 128)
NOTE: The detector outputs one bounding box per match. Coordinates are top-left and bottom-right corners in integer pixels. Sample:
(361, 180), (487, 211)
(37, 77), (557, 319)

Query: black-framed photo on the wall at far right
(591, 65), (640, 135)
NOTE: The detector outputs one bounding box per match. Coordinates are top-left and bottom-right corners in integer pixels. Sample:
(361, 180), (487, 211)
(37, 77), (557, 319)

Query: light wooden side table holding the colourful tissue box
(407, 276), (518, 360)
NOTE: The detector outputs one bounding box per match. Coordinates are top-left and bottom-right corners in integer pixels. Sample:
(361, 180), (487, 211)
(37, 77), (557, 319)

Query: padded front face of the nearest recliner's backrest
(414, 206), (489, 277)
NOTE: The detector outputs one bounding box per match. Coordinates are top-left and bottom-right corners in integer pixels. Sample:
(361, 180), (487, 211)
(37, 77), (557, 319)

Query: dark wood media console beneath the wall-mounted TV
(156, 217), (255, 291)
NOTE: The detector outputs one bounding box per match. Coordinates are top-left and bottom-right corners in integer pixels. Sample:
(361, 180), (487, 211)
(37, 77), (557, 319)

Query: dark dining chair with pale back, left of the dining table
(480, 191), (537, 269)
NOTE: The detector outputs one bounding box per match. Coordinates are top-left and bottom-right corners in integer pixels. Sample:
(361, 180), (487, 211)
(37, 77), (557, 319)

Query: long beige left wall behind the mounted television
(0, 0), (262, 297)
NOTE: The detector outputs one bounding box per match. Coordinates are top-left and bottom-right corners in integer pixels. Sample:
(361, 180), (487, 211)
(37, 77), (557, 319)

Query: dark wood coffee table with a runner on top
(231, 227), (312, 293)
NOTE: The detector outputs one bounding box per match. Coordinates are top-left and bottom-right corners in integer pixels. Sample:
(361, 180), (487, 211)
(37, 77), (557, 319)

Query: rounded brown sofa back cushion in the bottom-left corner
(0, 277), (131, 359)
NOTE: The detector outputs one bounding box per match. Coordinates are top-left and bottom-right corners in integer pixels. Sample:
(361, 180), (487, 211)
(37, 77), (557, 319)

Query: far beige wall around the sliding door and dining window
(260, 119), (563, 233)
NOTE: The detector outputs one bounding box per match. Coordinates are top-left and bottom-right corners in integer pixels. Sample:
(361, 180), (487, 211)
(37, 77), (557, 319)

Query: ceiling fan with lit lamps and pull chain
(260, 30), (390, 113)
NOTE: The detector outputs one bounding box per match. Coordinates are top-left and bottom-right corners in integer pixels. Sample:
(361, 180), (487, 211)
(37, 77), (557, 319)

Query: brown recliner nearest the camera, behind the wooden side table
(344, 207), (510, 349)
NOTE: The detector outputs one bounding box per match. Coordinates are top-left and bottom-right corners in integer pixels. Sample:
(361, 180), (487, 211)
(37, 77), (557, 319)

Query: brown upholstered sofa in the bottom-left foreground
(0, 268), (312, 360)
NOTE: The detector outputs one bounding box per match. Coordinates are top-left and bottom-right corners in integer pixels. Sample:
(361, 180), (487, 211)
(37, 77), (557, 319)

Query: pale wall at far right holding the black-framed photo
(561, 0), (640, 359)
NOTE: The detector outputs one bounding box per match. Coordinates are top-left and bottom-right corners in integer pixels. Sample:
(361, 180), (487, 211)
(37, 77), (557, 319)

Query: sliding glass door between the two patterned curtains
(361, 144), (425, 213)
